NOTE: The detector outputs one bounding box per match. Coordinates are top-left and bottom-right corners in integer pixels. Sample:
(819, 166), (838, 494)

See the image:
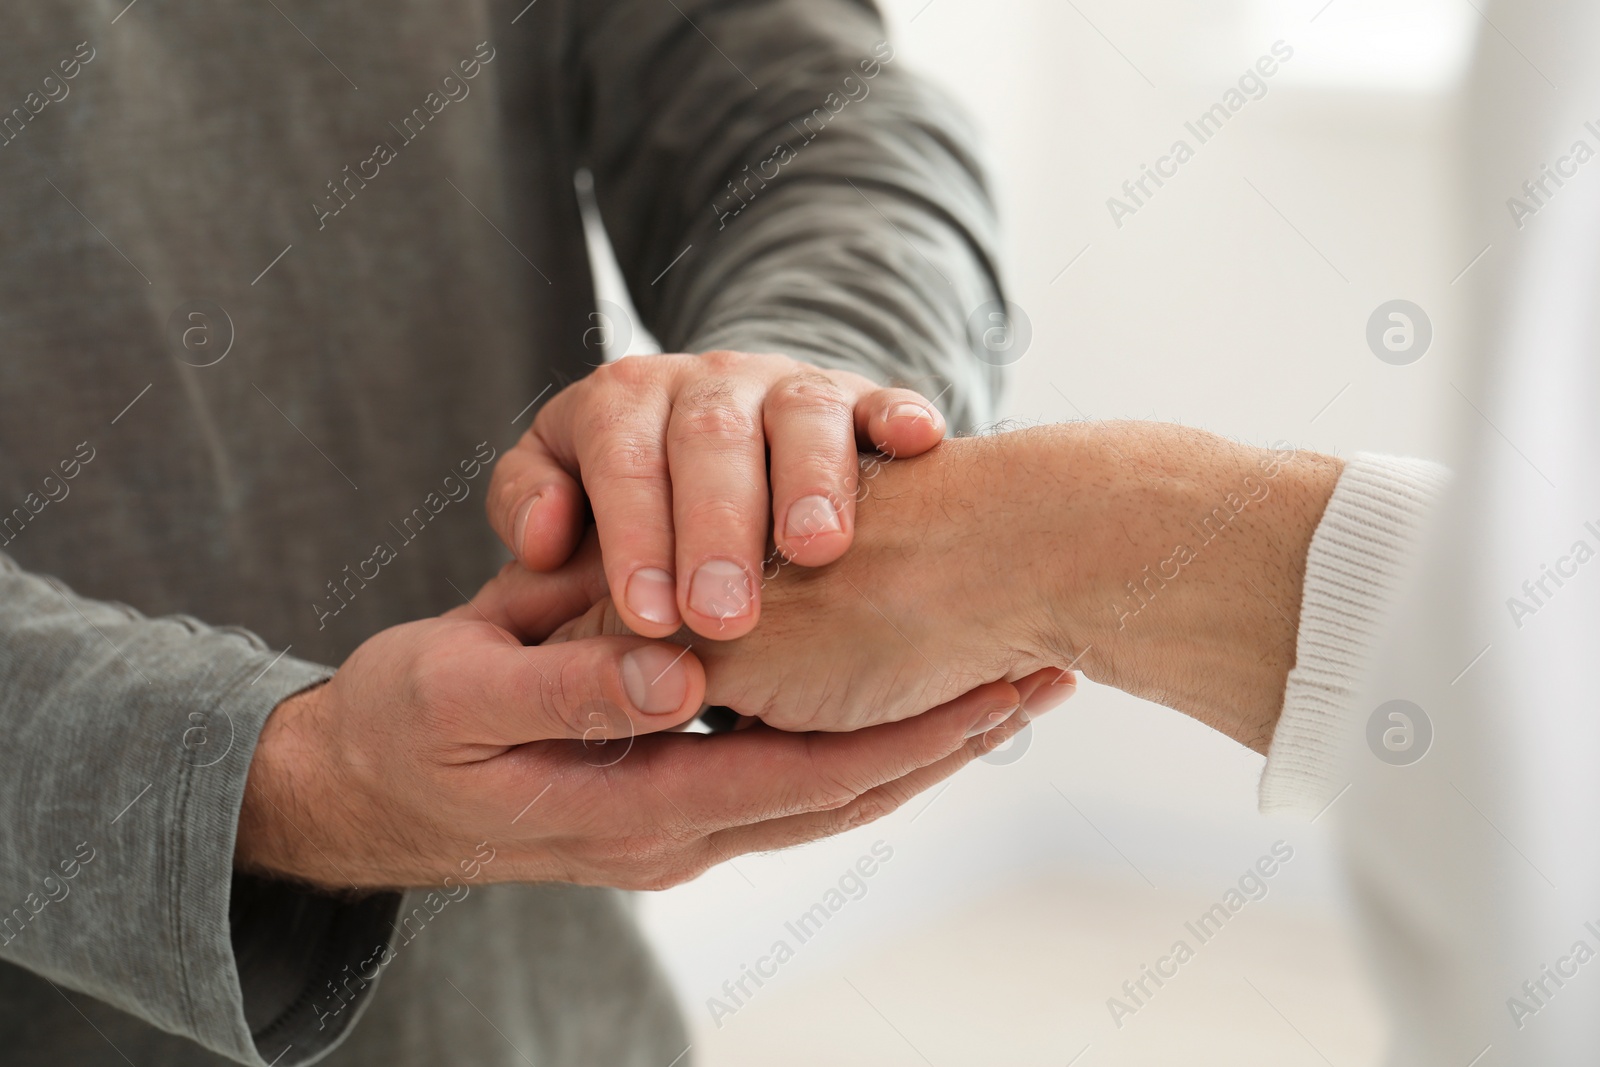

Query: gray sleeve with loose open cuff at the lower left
(0, 555), (398, 1065)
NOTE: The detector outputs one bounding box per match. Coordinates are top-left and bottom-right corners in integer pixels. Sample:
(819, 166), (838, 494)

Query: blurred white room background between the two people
(602, 0), (1484, 1067)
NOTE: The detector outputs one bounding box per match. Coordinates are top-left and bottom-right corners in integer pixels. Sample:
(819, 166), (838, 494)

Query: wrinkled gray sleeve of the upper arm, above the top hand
(578, 0), (1000, 429)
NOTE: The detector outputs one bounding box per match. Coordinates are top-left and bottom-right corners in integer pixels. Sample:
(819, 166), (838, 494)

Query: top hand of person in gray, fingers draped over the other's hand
(488, 352), (944, 640)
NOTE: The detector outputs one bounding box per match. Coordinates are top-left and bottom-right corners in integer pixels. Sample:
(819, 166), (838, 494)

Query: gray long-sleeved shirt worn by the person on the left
(0, 0), (997, 1067)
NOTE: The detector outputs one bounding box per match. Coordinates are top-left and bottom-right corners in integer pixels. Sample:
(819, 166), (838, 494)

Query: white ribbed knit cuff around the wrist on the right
(1259, 453), (1450, 816)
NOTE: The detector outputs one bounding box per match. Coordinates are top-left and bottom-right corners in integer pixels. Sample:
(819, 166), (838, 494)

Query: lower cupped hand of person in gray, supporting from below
(235, 544), (1026, 889)
